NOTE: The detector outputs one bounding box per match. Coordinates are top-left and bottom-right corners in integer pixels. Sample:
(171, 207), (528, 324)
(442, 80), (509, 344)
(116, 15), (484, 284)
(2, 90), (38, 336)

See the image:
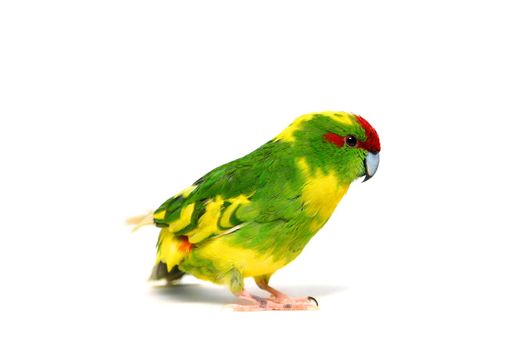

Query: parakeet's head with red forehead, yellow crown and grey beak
(275, 111), (380, 182)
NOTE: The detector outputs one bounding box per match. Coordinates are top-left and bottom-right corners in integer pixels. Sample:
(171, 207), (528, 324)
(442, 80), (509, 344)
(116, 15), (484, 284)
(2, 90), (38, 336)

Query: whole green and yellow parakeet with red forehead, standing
(129, 111), (380, 310)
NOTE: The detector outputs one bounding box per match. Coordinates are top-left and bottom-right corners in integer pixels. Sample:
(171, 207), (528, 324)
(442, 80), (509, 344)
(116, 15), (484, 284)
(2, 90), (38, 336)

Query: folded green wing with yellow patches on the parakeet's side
(154, 142), (301, 243)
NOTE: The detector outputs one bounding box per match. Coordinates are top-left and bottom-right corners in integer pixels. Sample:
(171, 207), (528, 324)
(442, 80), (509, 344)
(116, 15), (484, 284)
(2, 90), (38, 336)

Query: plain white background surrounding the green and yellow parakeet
(0, 0), (529, 349)
